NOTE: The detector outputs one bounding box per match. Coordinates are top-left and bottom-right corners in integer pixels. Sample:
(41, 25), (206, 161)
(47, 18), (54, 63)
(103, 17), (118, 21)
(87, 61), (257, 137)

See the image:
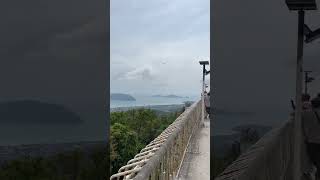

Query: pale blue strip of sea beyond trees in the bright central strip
(110, 95), (200, 108)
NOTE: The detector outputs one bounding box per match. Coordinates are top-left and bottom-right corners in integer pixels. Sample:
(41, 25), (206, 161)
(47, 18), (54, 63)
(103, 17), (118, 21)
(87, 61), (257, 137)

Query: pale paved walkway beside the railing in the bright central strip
(178, 116), (210, 180)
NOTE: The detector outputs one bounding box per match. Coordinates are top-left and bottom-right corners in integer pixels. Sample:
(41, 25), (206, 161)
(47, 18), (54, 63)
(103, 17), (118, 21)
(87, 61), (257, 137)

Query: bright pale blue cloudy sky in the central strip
(110, 0), (210, 95)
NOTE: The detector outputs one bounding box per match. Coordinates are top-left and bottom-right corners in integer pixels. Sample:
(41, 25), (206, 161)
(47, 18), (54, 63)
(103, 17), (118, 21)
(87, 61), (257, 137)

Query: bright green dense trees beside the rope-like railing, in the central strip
(110, 109), (183, 174)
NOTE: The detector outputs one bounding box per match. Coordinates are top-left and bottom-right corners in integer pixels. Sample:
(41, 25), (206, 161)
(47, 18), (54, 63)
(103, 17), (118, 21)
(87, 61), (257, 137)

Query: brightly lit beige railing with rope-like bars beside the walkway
(110, 101), (201, 180)
